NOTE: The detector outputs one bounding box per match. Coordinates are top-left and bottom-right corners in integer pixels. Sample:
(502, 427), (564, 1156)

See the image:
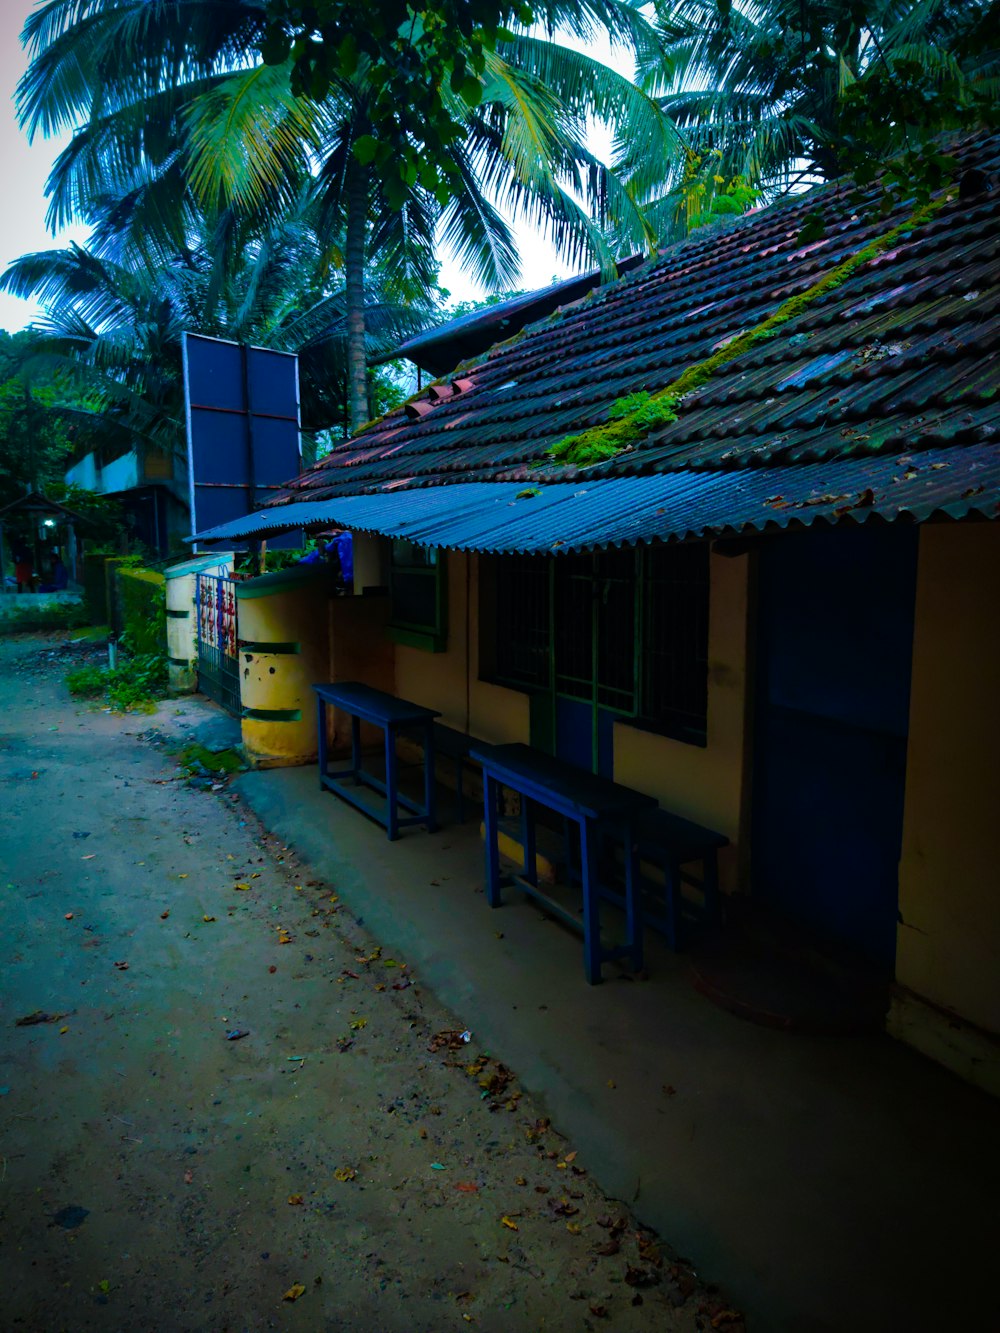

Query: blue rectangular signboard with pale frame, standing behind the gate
(183, 333), (303, 547)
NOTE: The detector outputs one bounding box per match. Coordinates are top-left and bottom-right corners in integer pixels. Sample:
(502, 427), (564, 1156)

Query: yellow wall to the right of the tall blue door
(896, 523), (1000, 1034)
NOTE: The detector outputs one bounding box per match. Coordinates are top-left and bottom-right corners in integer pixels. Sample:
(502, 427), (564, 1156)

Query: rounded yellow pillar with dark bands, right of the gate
(236, 565), (333, 766)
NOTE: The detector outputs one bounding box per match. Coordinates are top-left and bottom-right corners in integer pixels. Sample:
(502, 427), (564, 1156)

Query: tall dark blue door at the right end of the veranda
(752, 523), (917, 970)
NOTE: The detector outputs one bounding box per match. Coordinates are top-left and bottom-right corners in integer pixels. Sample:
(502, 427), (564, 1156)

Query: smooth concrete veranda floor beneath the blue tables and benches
(237, 769), (1000, 1333)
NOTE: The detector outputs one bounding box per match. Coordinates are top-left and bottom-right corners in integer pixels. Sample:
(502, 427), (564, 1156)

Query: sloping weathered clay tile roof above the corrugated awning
(276, 137), (1000, 514)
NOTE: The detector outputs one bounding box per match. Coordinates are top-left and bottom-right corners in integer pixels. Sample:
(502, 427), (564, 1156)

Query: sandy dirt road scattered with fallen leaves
(0, 639), (743, 1333)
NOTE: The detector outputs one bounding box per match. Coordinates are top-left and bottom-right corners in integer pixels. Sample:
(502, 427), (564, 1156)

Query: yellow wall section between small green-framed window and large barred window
(396, 551), (529, 744)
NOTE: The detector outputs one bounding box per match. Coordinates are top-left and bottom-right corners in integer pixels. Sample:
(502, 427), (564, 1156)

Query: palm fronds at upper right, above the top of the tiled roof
(639, 0), (996, 217)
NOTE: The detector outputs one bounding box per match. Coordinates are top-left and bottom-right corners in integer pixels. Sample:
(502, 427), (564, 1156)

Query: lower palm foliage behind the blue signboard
(0, 200), (429, 469)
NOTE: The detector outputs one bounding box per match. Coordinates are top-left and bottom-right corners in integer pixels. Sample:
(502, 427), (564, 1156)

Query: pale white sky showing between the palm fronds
(0, 0), (628, 332)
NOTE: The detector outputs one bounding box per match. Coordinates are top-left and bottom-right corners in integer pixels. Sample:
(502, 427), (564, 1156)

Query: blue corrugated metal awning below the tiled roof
(192, 444), (1000, 553)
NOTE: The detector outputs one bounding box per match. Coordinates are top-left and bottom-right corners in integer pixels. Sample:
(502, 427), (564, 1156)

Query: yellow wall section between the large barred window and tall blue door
(615, 553), (748, 892)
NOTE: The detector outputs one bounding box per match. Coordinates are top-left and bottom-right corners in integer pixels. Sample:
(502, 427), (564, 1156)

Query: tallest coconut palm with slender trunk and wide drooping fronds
(19, 0), (675, 428)
